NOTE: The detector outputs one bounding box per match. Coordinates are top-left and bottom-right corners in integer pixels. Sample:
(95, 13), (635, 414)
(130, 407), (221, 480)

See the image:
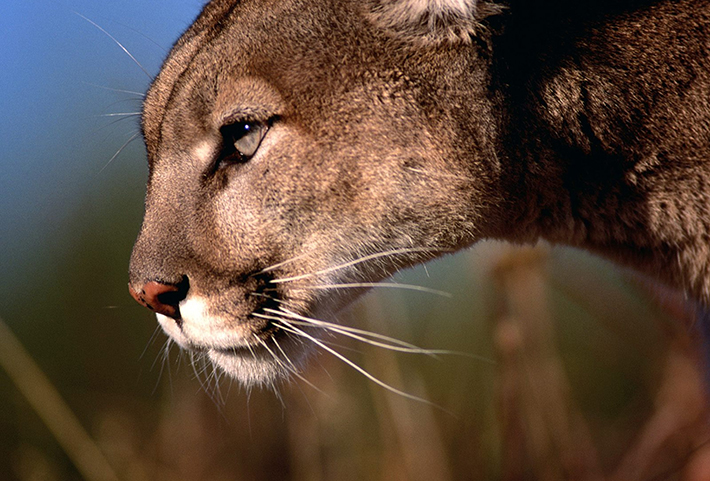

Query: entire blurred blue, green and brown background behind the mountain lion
(0, 0), (710, 481)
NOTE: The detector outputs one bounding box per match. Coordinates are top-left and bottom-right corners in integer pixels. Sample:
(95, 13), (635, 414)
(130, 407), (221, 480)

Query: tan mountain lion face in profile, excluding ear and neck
(131, 0), (506, 382)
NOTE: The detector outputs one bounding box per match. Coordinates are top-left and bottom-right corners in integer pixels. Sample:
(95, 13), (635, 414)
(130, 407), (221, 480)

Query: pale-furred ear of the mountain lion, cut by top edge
(370, 0), (502, 42)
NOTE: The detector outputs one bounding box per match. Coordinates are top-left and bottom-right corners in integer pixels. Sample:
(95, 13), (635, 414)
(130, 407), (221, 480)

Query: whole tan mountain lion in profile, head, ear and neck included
(130, 0), (710, 384)
